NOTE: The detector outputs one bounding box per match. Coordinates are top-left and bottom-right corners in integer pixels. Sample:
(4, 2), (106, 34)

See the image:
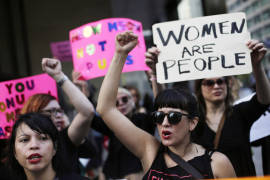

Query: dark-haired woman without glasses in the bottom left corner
(9, 113), (87, 180)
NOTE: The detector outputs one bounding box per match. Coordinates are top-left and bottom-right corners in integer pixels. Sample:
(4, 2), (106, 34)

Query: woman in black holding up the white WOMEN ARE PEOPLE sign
(146, 40), (270, 176)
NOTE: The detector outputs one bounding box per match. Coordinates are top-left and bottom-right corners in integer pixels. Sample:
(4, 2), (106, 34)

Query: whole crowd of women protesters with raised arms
(0, 28), (270, 180)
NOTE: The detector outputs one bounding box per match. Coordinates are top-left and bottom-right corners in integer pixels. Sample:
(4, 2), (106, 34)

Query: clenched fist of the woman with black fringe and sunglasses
(115, 31), (138, 55)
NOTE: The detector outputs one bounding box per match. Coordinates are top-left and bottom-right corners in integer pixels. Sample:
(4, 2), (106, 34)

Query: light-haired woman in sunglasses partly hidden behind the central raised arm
(73, 71), (155, 180)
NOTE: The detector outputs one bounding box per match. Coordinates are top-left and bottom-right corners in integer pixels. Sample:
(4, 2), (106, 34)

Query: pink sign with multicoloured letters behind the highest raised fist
(69, 18), (148, 79)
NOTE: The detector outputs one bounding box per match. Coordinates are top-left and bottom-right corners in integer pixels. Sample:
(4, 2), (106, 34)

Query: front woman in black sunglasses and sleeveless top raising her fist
(97, 32), (235, 179)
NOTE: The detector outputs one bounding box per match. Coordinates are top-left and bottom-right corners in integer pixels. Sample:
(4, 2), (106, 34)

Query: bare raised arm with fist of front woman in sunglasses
(97, 32), (158, 169)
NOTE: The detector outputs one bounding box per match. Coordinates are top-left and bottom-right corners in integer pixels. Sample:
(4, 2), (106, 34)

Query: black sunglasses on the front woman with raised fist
(152, 111), (190, 125)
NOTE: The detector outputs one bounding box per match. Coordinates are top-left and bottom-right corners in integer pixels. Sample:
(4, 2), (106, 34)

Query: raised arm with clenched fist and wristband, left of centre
(42, 58), (94, 145)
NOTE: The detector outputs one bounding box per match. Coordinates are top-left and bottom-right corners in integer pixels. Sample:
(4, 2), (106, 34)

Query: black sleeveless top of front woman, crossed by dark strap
(143, 145), (214, 180)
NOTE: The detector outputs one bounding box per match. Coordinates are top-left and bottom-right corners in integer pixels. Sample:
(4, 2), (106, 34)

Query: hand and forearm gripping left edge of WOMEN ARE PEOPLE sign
(145, 47), (165, 97)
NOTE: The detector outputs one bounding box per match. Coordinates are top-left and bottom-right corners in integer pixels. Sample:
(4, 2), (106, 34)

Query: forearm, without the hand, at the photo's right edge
(253, 64), (270, 104)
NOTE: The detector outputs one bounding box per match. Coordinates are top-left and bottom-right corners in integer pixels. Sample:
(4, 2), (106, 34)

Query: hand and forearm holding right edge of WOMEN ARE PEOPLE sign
(247, 40), (270, 104)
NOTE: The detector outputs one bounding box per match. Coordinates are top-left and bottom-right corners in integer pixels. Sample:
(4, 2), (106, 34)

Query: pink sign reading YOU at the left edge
(0, 74), (57, 139)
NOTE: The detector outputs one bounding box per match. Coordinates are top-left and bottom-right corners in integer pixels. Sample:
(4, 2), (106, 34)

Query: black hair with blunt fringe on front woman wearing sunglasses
(154, 89), (199, 118)
